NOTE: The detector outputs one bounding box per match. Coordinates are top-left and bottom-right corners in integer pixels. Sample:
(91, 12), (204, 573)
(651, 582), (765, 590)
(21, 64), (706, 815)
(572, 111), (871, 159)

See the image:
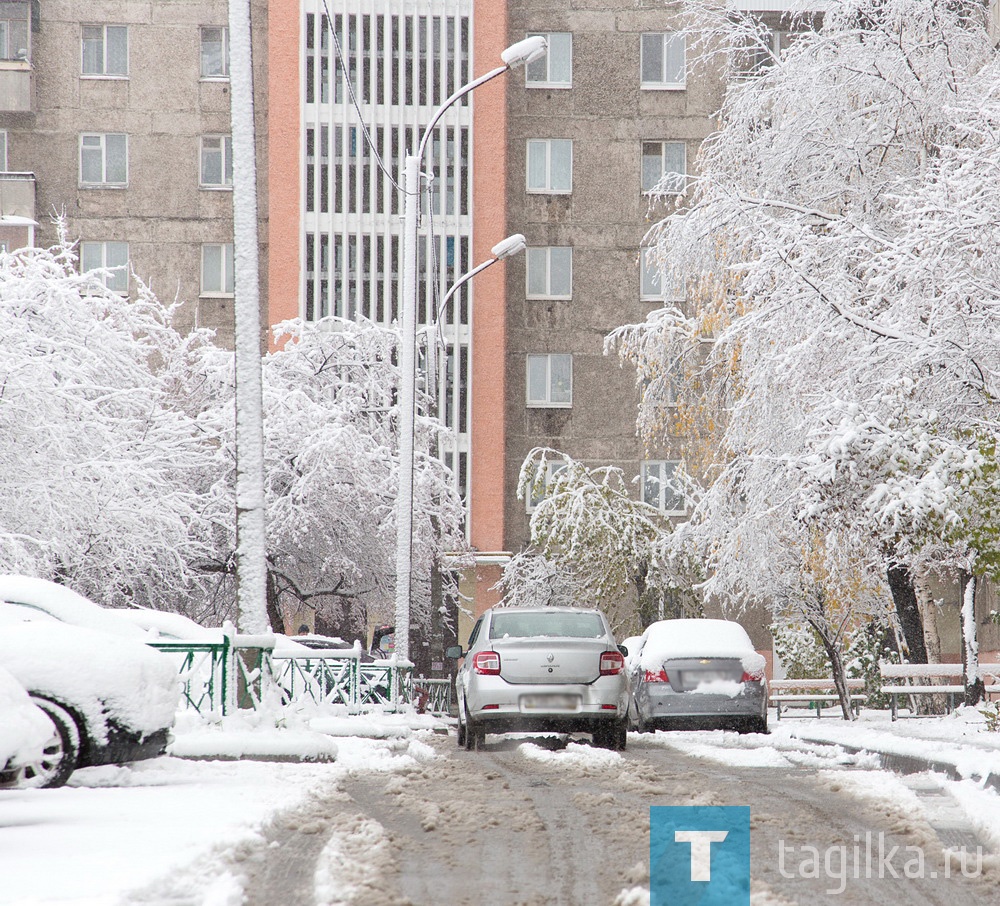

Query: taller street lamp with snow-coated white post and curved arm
(395, 35), (548, 660)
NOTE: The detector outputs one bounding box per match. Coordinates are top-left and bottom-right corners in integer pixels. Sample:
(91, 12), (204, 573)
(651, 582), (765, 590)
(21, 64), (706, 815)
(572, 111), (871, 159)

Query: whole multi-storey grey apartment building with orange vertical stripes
(0, 0), (719, 628)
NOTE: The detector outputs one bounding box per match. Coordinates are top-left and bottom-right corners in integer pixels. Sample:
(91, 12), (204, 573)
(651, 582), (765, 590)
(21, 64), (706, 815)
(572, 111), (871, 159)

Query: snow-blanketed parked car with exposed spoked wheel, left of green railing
(0, 602), (181, 787)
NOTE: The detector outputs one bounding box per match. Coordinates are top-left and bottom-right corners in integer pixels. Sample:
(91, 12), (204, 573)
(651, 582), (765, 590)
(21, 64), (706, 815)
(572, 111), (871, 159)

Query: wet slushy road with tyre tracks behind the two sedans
(236, 733), (1000, 906)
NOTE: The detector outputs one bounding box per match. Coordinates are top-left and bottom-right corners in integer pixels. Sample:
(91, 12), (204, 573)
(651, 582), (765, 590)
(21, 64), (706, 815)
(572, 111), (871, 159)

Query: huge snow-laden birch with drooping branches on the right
(616, 0), (1000, 708)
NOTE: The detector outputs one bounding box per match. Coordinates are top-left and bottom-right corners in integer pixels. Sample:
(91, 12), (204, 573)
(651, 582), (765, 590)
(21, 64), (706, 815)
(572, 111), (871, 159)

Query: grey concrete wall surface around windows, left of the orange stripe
(0, 0), (268, 345)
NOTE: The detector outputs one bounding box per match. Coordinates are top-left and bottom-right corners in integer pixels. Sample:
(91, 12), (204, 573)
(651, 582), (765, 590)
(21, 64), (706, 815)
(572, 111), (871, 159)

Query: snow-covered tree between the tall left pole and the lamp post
(195, 318), (464, 631)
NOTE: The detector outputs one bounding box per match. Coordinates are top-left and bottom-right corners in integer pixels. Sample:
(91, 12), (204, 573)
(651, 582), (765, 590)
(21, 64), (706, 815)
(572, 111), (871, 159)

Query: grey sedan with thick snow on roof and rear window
(630, 619), (767, 733)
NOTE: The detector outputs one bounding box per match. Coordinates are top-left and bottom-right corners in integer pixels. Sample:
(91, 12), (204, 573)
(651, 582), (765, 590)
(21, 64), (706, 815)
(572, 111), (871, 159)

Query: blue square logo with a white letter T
(649, 805), (750, 906)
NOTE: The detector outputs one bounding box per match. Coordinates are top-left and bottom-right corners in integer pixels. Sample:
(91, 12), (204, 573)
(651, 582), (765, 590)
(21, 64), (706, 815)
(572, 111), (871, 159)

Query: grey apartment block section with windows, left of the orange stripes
(0, 0), (267, 344)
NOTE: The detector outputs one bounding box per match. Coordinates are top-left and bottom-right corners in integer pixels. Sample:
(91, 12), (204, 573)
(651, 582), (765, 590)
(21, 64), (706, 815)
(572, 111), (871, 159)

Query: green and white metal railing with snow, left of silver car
(149, 623), (451, 717)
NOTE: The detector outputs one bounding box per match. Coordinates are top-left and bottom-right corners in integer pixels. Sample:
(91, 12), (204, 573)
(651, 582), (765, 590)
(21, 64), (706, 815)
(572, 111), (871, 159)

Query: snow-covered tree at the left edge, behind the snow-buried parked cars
(0, 235), (219, 609)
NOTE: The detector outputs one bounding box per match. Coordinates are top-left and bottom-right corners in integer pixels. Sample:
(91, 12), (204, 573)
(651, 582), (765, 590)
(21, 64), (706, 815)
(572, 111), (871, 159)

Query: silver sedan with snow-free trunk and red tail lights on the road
(447, 607), (629, 750)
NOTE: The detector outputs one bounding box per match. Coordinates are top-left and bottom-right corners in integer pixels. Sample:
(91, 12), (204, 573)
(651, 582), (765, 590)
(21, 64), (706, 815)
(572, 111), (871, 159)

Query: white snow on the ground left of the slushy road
(0, 715), (442, 906)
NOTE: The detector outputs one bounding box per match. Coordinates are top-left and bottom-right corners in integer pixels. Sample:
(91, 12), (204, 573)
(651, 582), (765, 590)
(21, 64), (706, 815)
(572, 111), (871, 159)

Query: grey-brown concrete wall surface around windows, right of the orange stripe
(504, 0), (722, 550)
